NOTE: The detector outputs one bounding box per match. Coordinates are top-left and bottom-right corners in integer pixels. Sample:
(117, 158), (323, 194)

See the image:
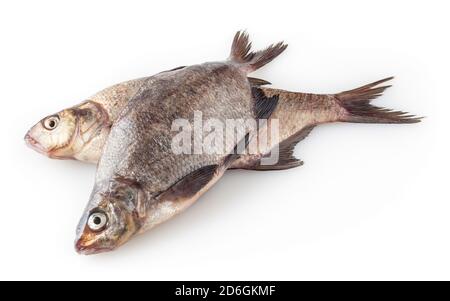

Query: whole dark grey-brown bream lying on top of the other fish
(75, 32), (287, 254)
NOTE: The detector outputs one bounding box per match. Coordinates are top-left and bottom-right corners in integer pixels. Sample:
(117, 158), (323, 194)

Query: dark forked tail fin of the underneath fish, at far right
(334, 77), (423, 123)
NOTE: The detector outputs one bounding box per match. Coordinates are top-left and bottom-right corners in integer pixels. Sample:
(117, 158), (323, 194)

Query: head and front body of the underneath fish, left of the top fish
(24, 78), (141, 164)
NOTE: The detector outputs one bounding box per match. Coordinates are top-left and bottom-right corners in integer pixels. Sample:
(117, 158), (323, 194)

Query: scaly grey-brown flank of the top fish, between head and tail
(97, 63), (254, 191)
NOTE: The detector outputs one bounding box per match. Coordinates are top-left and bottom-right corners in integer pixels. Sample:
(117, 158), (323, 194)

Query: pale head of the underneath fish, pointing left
(24, 101), (108, 161)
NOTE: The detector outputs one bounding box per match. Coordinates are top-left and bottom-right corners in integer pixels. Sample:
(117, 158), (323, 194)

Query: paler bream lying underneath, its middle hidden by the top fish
(25, 72), (421, 170)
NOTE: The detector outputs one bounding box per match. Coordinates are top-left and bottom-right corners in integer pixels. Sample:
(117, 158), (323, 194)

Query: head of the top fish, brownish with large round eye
(75, 182), (143, 255)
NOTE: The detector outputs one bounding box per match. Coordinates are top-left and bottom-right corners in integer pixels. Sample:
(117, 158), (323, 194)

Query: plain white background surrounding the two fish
(0, 0), (450, 280)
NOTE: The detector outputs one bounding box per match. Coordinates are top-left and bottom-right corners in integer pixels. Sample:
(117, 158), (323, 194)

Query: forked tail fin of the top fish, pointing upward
(229, 31), (287, 73)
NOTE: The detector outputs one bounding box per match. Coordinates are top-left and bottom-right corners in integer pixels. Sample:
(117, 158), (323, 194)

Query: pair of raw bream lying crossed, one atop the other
(25, 32), (420, 254)
